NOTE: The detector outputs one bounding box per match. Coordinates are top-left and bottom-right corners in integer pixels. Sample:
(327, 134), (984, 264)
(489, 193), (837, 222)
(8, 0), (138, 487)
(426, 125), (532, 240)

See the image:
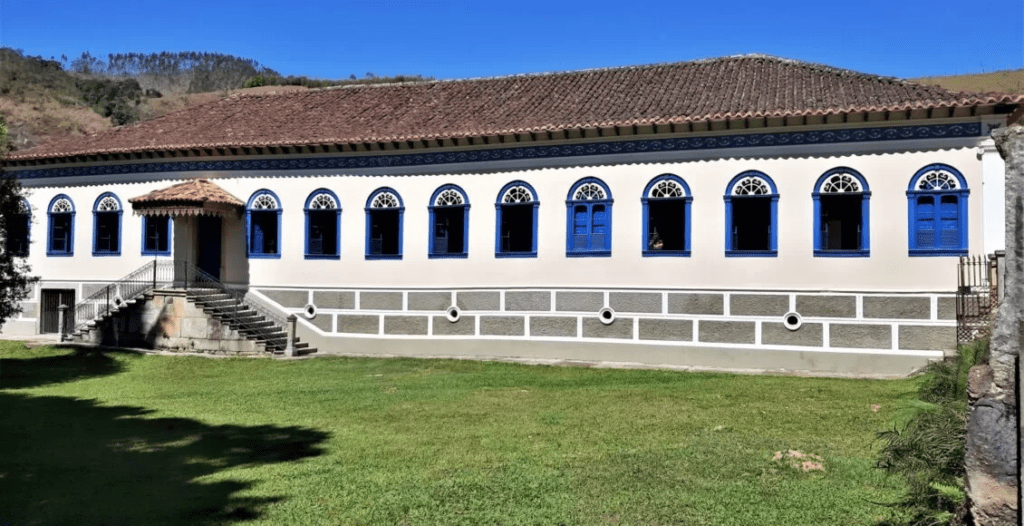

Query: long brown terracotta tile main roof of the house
(10, 55), (1024, 160)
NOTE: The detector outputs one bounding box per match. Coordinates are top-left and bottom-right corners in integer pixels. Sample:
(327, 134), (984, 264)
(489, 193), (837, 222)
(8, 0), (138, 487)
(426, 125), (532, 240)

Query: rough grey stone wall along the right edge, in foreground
(965, 126), (1024, 526)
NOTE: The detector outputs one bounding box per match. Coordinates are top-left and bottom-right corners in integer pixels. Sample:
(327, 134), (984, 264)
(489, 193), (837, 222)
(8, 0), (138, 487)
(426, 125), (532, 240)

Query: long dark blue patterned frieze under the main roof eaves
(14, 123), (982, 179)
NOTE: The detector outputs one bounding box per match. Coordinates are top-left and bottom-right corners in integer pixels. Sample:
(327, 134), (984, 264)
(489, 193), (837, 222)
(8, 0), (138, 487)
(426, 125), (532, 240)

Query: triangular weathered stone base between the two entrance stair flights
(79, 291), (265, 354)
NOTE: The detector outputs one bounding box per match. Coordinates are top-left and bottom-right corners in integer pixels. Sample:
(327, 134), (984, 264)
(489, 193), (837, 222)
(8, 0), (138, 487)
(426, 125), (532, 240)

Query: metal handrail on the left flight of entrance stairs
(73, 261), (174, 331)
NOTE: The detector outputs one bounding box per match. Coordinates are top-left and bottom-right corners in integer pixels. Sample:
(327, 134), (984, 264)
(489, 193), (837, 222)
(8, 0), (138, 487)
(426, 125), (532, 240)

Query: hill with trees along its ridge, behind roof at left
(0, 47), (428, 149)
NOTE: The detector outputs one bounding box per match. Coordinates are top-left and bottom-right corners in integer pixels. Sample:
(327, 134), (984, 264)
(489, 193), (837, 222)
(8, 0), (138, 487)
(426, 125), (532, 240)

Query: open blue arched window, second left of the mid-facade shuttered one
(427, 184), (469, 258)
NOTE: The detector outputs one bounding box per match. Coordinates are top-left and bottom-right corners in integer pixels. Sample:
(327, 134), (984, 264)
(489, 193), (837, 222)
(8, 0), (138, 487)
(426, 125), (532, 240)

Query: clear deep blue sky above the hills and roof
(0, 0), (1024, 79)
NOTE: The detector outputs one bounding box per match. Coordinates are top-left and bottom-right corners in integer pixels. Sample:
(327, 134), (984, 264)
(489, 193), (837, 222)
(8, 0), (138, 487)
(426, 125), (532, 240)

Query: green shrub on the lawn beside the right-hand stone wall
(878, 341), (988, 526)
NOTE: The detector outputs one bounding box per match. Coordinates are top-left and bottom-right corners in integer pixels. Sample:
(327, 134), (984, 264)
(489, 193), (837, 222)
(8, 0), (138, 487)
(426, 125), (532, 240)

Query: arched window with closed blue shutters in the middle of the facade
(565, 177), (612, 257)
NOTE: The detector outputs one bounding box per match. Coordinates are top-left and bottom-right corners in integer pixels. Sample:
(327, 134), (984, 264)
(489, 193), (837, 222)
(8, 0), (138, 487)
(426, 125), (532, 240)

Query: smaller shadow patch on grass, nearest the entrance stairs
(0, 347), (126, 389)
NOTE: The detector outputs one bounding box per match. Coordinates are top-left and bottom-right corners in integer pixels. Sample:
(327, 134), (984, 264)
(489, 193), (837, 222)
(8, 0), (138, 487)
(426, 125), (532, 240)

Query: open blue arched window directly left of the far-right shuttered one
(811, 167), (871, 258)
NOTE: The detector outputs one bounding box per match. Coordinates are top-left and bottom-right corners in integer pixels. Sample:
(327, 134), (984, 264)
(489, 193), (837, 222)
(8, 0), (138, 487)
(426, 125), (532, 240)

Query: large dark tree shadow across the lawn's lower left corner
(0, 391), (328, 526)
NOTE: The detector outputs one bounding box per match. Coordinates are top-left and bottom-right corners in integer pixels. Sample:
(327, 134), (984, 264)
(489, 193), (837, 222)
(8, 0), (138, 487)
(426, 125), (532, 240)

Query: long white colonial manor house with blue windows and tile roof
(3, 55), (1024, 374)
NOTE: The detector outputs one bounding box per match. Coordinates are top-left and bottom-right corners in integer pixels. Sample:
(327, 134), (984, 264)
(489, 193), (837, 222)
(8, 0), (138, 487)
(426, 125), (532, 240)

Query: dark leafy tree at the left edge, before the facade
(0, 120), (39, 325)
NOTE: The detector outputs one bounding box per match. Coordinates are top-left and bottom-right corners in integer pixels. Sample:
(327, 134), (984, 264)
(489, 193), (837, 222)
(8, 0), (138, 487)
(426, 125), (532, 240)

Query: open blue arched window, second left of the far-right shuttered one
(725, 170), (778, 254)
